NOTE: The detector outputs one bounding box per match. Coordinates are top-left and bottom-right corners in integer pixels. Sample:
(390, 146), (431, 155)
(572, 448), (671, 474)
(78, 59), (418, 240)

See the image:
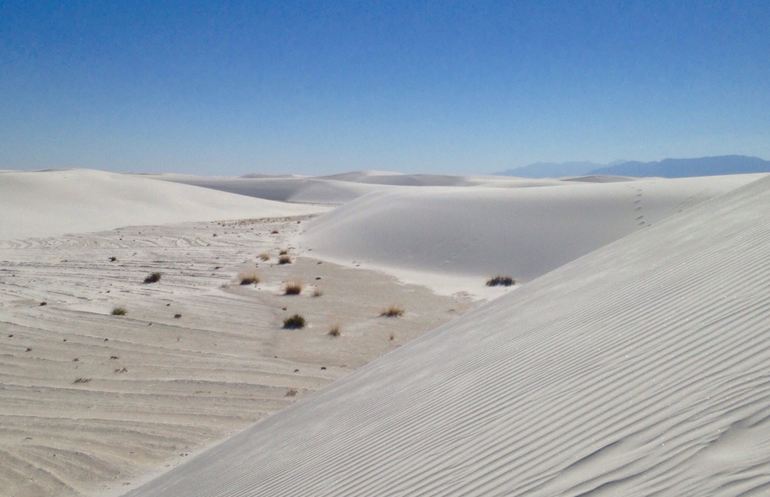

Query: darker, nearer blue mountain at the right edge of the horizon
(588, 155), (770, 178)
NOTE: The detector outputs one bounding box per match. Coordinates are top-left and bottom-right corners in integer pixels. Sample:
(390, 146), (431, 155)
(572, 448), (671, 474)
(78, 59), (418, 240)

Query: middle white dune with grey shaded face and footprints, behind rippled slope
(302, 175), (761, 291)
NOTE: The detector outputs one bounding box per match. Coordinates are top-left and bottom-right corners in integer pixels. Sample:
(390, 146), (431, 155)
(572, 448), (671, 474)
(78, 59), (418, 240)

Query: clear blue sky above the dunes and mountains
(0, 0), (770, 174)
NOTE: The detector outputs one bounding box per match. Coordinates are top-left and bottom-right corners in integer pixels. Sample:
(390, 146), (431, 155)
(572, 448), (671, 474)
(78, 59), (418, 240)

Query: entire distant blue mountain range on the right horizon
(497, 155), (770, 178)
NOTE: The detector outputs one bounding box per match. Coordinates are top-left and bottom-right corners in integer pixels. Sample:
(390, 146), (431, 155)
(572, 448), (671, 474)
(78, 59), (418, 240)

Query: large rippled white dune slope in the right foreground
(123, 174), (770, 497)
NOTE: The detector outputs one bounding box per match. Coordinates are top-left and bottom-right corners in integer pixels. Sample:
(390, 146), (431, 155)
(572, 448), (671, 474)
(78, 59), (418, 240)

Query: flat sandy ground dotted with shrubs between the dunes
(0, 213), (471, 497)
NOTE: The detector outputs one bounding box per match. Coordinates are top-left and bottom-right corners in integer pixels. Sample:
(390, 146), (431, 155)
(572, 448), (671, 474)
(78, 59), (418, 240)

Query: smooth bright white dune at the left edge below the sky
(0, 169), (323, 239)
